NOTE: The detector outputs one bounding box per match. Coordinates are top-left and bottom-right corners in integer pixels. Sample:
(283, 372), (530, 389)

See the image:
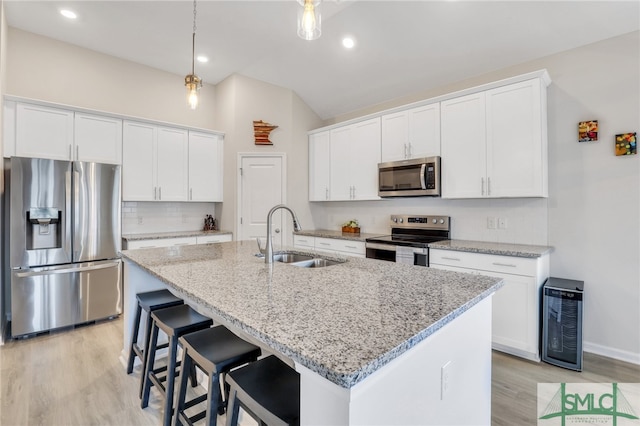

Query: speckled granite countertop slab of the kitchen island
(123, 241), (502, 388)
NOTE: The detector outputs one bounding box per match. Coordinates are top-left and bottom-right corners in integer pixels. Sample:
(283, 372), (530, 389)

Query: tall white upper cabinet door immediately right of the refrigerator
(122, 121), (157, 201)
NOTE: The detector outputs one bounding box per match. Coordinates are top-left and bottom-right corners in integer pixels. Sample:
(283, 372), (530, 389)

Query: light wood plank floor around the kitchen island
(0, 319), (640, 426)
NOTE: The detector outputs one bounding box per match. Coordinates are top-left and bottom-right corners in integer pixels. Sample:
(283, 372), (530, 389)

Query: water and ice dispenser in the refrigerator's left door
(26, 207), (62, 250)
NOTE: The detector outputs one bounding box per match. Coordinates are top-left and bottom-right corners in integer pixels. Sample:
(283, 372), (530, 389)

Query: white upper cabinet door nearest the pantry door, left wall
(189, 132), (223, 201)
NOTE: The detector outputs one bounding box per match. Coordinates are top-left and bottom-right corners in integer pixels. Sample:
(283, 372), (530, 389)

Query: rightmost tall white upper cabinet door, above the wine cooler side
(486, 79), (547, 197)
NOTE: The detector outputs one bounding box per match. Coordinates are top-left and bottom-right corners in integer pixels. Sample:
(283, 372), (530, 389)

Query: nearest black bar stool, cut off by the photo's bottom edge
(227, 356), (300, 426)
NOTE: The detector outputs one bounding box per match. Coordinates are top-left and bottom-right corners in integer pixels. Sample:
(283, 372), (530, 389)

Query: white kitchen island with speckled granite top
(123, 241), (501, 425)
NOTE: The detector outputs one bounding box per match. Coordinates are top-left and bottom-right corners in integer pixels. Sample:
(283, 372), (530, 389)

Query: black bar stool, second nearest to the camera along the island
(173, 326), (261, 426)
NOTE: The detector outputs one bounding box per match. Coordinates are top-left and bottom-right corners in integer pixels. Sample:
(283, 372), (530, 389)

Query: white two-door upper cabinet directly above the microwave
(381, 102), (440, 163)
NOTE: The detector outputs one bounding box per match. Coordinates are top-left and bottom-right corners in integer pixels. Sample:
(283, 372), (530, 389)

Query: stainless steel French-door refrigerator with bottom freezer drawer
(5, 157), (122, 337)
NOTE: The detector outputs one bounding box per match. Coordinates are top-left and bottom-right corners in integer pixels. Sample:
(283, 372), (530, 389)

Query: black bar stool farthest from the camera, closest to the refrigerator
(127, 290), (184, 382)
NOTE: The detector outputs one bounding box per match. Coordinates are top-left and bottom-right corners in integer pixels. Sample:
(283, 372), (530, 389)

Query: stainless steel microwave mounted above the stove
(378, 157), (440, 197)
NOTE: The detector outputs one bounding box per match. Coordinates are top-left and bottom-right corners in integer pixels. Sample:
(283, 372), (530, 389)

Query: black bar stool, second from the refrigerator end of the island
(140, 305), (213, 426)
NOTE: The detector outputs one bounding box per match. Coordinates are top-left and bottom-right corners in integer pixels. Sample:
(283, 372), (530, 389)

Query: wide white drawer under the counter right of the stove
(429, 249), (537, 277)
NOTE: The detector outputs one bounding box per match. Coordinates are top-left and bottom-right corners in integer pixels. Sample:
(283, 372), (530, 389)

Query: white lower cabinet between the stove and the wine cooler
(429, 249), (549, 361)
